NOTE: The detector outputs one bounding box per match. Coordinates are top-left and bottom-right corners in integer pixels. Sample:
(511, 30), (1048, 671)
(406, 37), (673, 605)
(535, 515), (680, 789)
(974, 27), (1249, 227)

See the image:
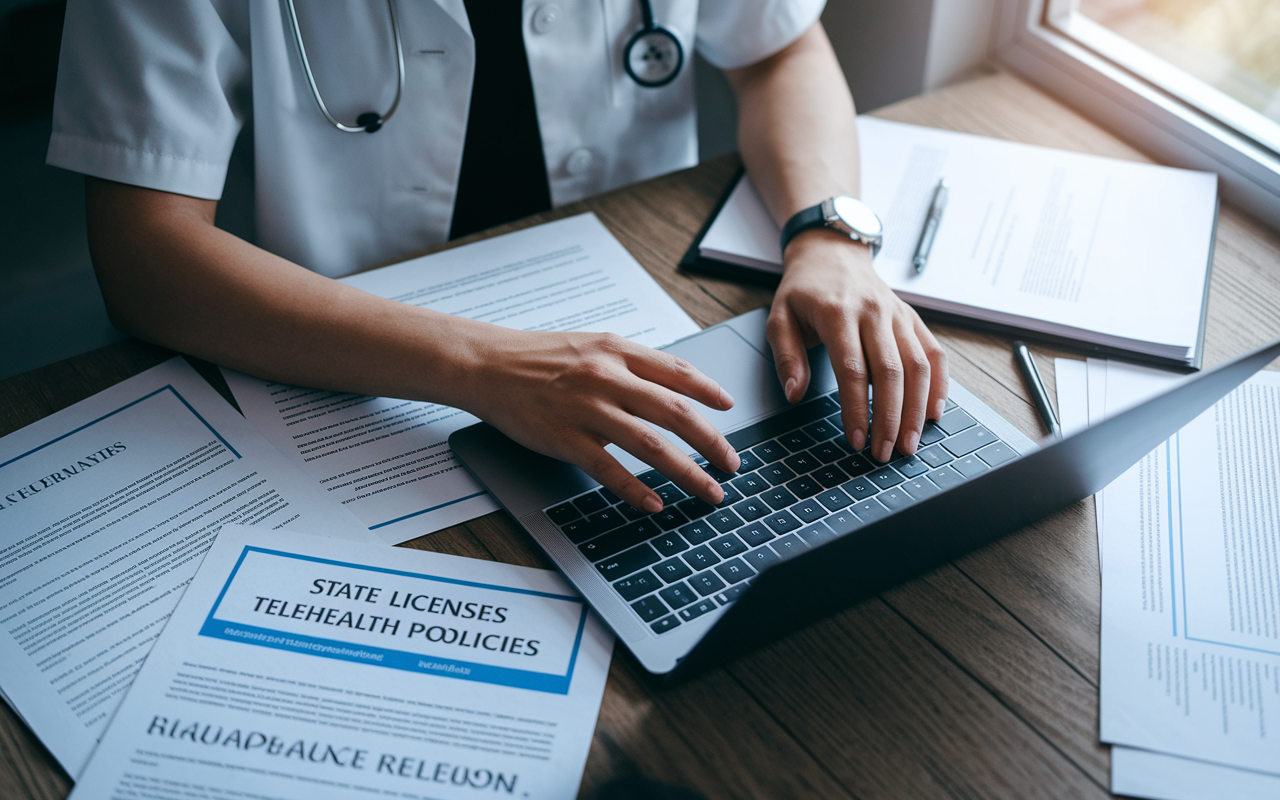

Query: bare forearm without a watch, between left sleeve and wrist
(87, 179), (481, 404)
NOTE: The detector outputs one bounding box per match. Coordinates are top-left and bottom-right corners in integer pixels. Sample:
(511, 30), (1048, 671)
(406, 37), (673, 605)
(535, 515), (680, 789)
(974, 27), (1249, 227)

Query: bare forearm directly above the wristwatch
(727, 23), (859, 225)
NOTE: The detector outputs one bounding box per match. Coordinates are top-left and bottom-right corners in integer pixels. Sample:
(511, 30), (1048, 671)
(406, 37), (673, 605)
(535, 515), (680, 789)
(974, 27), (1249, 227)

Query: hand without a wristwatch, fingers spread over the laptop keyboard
(462, 325), (741, 512)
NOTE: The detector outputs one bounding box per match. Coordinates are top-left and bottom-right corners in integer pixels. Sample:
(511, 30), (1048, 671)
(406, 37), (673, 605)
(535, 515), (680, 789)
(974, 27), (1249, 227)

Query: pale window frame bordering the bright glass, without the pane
(996, 0), (1280, 228)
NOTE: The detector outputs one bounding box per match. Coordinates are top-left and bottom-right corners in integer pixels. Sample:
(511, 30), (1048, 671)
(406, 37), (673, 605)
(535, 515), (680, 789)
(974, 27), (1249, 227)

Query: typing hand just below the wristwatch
(767, 229), (947, 462)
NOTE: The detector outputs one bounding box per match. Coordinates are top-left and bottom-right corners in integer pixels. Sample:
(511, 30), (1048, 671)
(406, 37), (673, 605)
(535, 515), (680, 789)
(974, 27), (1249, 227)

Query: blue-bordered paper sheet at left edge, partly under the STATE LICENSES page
(0, 358), (376, 777)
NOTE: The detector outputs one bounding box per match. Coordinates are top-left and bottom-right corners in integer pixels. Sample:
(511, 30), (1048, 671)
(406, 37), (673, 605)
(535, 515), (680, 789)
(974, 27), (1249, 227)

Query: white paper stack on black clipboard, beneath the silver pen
(699, 115), (1217, 361)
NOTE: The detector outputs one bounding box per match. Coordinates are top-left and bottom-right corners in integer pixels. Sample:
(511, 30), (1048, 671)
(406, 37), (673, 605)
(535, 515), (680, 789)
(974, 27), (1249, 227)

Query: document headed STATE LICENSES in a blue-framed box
(72, 525), (613, 800)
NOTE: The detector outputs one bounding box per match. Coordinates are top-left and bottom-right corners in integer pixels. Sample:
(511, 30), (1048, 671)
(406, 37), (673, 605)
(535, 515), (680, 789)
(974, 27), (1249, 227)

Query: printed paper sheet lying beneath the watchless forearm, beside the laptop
(224, 214), (699, 543)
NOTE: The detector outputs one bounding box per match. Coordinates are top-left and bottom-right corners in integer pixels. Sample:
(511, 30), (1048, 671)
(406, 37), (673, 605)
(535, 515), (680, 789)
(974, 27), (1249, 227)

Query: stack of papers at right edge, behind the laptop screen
(1056, 360), (1280, 800)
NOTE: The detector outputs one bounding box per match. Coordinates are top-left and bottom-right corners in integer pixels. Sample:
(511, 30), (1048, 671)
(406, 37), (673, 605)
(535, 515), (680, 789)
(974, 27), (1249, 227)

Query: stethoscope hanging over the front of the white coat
(284, 0), (685, 133)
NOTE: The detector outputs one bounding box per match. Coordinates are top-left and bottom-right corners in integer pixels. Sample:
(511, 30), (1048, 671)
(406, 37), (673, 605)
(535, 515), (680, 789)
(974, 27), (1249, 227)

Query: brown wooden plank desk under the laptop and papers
(0, 74), (1280, 800)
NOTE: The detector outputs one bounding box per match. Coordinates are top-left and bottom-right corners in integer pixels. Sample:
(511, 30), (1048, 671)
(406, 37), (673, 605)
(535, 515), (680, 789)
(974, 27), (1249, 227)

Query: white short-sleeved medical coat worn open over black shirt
(49, 0), (823, 276)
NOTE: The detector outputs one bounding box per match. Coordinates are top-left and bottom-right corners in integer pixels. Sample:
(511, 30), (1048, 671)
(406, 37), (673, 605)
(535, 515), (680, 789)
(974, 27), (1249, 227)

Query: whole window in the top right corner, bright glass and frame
(997, 0), (1280, 227)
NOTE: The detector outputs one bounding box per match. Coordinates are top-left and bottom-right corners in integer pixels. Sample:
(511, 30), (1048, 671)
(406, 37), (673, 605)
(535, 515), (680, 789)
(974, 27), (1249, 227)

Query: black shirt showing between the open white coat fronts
(449, 0), (552, 239)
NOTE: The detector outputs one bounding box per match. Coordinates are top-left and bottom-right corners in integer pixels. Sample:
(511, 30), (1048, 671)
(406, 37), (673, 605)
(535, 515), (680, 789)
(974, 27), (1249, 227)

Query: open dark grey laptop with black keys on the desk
(449, 308), (1280, 682)
